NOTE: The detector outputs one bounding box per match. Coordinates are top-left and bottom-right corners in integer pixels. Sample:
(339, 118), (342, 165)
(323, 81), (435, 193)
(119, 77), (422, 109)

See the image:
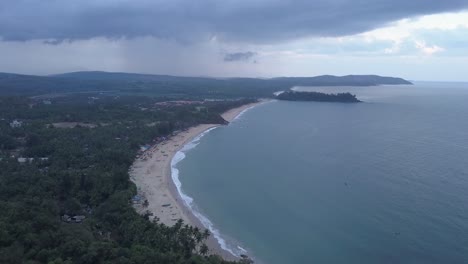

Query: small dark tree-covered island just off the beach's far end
(276, 91), (362, 103)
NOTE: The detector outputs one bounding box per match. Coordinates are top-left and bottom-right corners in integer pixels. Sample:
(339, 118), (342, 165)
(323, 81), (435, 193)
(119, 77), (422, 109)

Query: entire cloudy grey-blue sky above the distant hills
(0, 0), (468, 81)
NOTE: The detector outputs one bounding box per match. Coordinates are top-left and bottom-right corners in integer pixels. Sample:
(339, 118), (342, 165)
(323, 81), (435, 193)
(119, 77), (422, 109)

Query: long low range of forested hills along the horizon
(0, 71), (411, 98)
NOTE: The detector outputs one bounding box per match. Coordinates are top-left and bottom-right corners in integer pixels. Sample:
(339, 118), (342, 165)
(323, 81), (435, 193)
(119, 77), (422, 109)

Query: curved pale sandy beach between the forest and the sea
(129, 100), (267, 260)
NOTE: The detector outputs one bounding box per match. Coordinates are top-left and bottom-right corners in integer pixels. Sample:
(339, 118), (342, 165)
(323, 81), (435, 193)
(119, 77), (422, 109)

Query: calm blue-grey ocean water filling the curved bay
(173, 82), (468, 264)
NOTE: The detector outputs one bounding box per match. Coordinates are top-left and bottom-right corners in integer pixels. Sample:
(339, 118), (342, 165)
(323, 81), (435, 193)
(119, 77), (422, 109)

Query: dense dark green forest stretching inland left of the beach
(0, 94), (254, 264)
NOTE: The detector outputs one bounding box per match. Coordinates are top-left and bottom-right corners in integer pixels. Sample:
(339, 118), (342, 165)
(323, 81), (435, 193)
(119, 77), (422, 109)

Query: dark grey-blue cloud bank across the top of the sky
(0, 0), (468, 43)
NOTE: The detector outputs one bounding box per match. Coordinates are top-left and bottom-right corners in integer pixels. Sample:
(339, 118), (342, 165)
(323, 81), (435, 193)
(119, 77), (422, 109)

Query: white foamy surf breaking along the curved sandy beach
(171, 127), (245, 257)
